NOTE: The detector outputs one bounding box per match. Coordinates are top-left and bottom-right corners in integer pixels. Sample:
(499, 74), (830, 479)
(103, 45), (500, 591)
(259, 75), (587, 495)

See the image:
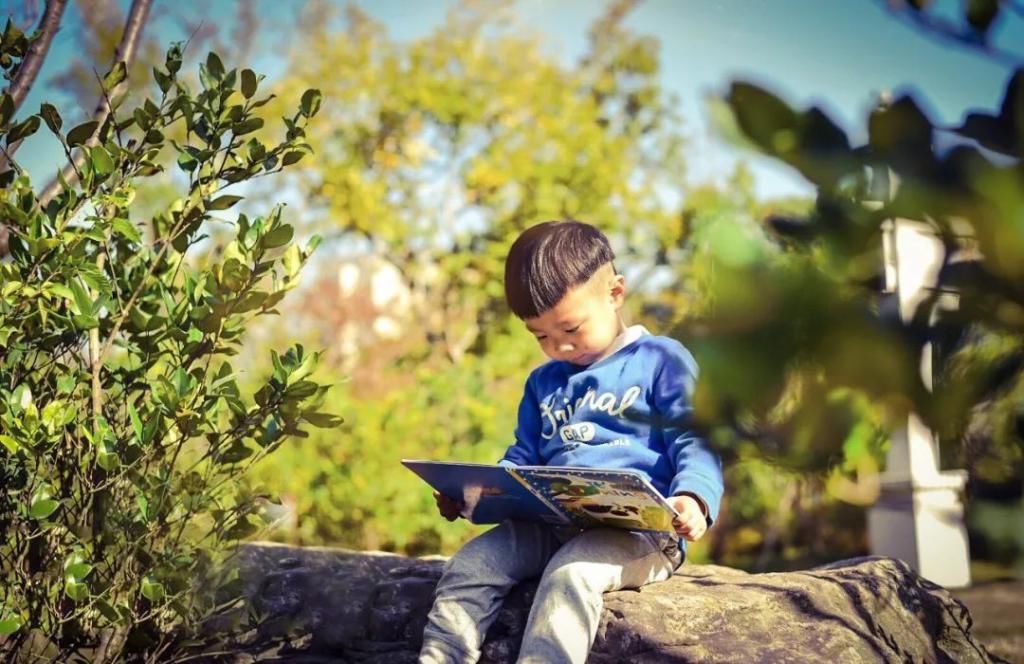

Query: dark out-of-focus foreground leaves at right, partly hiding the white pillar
(679, 2), (1024, 541)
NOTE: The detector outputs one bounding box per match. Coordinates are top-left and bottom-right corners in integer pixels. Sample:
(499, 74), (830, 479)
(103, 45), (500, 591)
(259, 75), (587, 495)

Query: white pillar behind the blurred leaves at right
(867, 219), (971, 588)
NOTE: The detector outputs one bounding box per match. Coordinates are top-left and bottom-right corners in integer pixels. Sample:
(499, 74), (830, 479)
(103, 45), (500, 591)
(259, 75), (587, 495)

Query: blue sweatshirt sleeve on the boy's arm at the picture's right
(652, 346), (724, 526)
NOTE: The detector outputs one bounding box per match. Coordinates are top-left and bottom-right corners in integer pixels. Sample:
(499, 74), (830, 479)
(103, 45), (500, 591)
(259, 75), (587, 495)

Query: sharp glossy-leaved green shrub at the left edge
(0, 41), (336, 661)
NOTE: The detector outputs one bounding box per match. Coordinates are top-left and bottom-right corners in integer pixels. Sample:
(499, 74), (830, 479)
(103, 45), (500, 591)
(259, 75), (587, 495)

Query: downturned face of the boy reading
(525, 264), (626, 366)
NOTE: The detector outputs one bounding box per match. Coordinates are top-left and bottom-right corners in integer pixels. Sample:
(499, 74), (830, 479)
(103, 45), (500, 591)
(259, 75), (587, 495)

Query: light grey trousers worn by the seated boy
(420, 522), (683, 664)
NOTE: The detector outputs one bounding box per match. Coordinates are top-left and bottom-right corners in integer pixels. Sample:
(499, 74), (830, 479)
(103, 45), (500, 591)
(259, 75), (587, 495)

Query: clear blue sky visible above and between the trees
(19, 0), (1024, 196)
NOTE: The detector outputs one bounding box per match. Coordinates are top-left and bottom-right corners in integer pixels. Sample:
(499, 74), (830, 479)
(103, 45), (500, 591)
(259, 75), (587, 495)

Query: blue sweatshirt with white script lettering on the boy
(500, 326), (723, 525)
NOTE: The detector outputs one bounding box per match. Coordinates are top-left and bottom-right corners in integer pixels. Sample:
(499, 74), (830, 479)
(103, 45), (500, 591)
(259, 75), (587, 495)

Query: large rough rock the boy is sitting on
(228, 544), (1002, 664)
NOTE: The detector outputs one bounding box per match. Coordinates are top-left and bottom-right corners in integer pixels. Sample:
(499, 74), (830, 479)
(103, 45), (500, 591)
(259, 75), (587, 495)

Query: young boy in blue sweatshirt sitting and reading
(420, 221), (723, 664)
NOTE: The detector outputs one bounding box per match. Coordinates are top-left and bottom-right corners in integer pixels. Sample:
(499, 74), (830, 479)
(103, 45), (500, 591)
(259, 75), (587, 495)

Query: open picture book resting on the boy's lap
(401, 459), (676, 533)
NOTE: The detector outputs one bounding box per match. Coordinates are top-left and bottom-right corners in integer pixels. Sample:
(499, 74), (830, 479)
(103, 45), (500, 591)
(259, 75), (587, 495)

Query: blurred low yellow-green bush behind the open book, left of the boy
(253, 326), (540, 554)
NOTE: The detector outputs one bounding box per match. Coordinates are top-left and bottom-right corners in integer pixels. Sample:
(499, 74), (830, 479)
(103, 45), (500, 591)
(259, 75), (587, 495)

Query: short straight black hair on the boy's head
(505, 220), (615, 319)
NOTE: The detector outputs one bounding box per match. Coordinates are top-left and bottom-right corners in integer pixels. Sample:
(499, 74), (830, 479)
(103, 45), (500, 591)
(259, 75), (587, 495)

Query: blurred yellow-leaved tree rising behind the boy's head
(260, 2), (683, 368)
